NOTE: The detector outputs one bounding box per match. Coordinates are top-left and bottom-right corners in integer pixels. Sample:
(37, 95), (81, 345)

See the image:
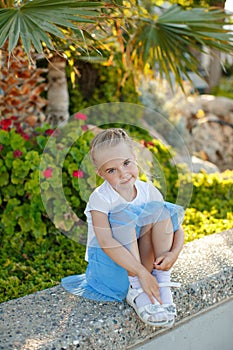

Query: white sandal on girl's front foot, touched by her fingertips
(126, 286), (169, 327)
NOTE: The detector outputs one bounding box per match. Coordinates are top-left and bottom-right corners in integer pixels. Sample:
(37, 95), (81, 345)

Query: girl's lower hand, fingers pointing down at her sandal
(138, 270), (162, 304)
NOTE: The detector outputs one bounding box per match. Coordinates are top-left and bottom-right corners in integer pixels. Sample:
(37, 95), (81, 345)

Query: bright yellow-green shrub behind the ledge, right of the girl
(180, 170), (233, 242)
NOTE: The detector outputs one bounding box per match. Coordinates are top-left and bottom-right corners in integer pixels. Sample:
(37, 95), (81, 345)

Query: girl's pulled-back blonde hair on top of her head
(90, 128), (133, 165)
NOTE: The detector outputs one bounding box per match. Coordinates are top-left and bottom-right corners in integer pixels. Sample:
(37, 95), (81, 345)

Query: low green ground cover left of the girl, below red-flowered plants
(0, 228), (86, 302)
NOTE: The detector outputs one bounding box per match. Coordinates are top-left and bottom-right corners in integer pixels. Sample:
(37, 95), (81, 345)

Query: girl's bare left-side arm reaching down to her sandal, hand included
(91, 210), (162, 303)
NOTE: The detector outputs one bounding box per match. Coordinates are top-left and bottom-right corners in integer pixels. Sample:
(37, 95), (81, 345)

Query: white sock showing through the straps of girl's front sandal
(129, 276), (167, 322)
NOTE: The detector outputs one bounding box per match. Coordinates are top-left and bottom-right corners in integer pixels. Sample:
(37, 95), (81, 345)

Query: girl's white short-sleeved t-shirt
(85, 180), (163, 260)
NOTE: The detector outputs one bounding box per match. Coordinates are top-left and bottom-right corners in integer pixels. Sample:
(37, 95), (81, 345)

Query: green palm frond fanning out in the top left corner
(0, 0), (104, 55)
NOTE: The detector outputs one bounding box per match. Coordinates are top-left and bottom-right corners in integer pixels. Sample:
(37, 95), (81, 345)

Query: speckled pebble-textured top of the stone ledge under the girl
(0, 230), (233, 350)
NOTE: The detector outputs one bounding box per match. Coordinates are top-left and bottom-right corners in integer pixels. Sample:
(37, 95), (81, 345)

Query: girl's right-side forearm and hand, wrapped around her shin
(154, 226), (184, 270)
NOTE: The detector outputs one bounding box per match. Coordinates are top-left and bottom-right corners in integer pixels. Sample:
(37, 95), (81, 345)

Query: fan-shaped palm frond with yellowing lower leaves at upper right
(127, 5), (233, 87)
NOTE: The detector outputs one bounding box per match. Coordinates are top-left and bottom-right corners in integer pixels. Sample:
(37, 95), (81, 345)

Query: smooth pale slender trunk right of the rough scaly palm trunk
(46, 55), (69, 127)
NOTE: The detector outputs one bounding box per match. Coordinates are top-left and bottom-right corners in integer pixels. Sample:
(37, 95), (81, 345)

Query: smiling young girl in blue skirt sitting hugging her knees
(62, 128), (184, 327)
